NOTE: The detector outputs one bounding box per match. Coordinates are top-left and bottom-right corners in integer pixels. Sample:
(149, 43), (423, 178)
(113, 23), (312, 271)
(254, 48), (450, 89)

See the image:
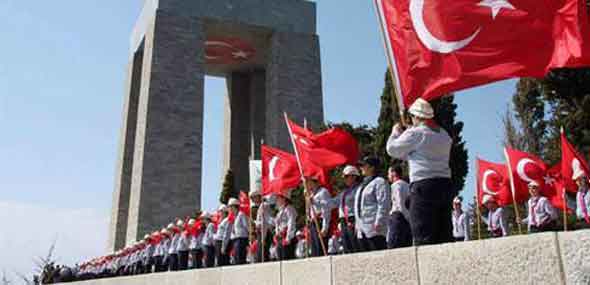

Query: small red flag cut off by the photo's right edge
(561, 132), (590, 192)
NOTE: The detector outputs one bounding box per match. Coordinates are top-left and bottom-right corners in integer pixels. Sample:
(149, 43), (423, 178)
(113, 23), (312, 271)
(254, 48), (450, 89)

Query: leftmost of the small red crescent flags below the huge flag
(476, 158), (512, 206)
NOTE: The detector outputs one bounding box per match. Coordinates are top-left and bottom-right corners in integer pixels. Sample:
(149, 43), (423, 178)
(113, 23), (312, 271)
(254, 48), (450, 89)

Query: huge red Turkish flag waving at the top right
(374, 0), (590, 107)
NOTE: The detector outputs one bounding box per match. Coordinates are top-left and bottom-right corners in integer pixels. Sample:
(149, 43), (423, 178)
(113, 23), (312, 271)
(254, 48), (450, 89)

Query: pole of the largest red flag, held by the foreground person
(373, 0), (406, 125)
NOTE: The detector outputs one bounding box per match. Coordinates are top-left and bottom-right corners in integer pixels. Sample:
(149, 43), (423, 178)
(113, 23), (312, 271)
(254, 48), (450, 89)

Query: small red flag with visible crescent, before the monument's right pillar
(261, 145), (301, 195)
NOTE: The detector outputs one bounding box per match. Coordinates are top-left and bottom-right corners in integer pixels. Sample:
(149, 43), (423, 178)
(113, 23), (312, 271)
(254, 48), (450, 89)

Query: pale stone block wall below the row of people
(60, 230), (590, 285)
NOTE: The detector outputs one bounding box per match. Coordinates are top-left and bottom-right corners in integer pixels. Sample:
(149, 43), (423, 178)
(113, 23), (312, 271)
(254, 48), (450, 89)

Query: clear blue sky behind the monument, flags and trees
(0, 0), (515, 276)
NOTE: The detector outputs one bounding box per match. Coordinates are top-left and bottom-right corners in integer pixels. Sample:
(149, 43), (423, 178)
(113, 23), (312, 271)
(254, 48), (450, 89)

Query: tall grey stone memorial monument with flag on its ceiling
(109, 0), (323, 250)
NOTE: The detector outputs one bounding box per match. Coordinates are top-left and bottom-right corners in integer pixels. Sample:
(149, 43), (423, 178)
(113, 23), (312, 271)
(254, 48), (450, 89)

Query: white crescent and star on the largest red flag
(410, 0), (515, 53)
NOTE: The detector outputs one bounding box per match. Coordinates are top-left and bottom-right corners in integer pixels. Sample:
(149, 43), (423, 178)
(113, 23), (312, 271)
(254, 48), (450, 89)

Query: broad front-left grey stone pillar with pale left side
(127, 10), (205, 244)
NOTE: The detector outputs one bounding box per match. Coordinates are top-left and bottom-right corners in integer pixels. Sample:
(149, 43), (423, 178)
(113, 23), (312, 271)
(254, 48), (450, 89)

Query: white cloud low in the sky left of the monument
(0, 201), (109, 281)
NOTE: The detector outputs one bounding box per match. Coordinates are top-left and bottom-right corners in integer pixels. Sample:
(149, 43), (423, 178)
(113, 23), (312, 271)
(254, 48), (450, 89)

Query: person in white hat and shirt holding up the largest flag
(387, 98), (456, 245)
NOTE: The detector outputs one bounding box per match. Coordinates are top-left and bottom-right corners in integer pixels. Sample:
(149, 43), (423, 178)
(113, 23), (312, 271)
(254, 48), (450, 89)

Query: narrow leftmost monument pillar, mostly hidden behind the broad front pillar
(107, 47), (143, 251)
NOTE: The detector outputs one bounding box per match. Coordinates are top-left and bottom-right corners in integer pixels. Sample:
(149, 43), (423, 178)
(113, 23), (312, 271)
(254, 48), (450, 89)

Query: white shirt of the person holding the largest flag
(387, 124), (453, 182)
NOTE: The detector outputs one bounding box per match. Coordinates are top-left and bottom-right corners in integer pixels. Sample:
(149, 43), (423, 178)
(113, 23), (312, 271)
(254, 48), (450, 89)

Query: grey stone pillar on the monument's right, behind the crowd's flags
(265, 32), (324, 150)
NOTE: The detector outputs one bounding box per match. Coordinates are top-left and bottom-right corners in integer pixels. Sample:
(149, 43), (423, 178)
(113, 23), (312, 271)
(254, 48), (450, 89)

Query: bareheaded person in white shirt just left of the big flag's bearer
(387, 165), (412, 249)
